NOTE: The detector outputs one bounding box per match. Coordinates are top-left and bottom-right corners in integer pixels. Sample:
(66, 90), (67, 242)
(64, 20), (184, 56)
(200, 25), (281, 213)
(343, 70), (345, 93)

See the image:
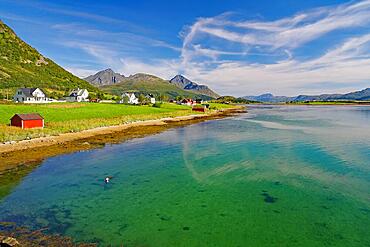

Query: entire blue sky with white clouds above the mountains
(0, 0), (370, 96)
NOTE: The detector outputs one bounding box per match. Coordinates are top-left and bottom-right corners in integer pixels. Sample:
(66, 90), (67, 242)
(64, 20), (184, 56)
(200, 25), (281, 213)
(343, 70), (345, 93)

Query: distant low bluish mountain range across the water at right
(242, 88), (370, 103)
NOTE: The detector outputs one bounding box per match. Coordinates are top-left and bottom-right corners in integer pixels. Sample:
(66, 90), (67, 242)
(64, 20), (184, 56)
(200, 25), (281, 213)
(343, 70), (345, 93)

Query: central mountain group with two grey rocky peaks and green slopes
(85, 69), (219, 99)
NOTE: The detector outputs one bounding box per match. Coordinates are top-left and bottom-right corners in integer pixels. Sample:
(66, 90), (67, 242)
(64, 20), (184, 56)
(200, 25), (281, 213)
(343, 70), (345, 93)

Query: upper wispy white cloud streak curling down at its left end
(184, 0), (370, 52)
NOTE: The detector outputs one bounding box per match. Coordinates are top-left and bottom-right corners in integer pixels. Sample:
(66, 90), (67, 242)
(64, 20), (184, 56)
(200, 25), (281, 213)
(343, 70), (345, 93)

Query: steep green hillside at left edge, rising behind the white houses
(0, 20), (99, 98)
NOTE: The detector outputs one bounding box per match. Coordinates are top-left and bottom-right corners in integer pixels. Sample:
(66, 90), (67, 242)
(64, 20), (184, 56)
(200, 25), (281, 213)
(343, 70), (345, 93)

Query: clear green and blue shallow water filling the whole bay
(0, 106), (370, 246)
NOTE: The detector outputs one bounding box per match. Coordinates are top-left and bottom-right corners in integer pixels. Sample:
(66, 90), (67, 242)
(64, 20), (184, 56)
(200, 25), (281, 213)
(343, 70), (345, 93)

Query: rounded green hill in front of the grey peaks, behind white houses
(100, 74), (211, 100)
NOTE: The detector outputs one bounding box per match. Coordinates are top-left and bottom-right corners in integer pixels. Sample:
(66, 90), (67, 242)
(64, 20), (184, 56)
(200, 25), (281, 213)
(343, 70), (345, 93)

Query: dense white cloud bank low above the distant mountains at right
(183, 34), (370, 95)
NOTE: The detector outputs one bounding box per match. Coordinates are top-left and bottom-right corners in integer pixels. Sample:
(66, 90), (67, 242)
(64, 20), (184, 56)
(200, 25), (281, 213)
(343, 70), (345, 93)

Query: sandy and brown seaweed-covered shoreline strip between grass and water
(0, 107), (245, 175)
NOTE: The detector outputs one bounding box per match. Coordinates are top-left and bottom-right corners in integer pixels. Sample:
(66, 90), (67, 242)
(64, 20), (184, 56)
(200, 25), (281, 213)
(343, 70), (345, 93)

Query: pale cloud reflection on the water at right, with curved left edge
(179, 106), (370, 203)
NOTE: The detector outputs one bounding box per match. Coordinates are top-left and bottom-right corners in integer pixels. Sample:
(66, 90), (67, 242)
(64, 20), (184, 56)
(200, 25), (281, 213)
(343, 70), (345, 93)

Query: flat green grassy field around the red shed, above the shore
(0, 103), (232, 142)
